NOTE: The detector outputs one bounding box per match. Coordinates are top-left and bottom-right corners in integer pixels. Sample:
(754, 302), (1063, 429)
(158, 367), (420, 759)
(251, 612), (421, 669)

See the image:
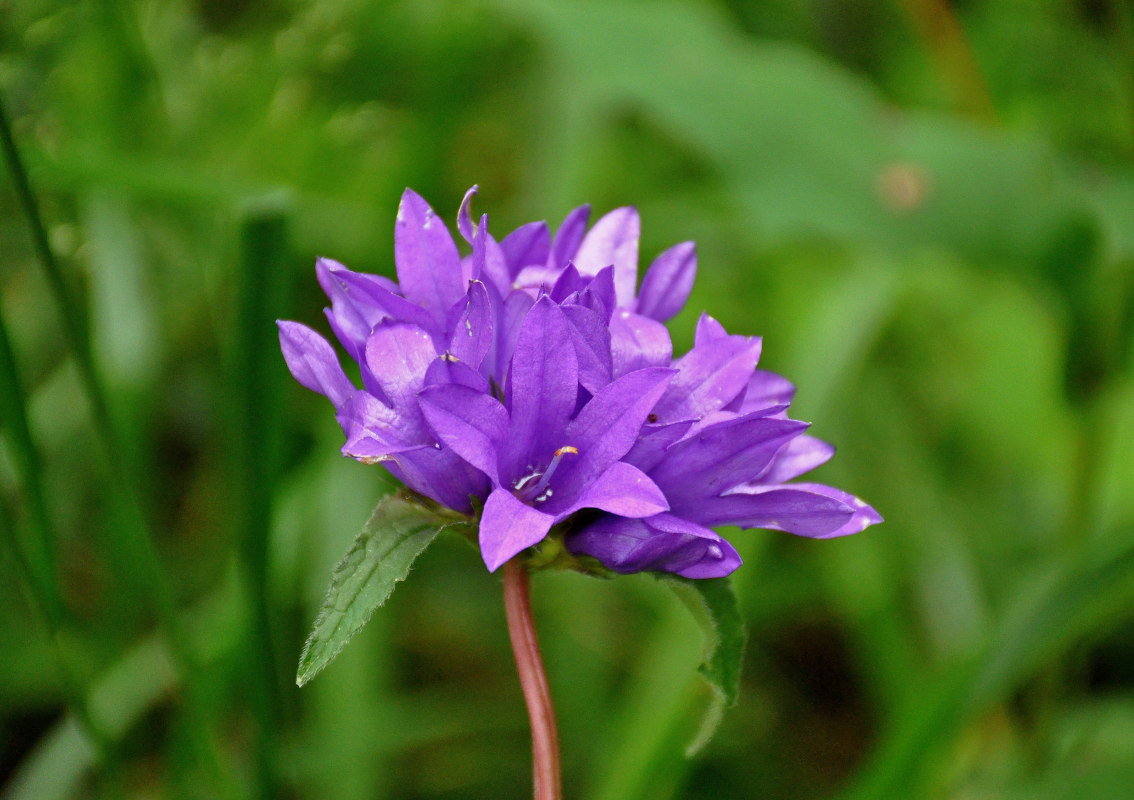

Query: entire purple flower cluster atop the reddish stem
(279, 187), (881, 578)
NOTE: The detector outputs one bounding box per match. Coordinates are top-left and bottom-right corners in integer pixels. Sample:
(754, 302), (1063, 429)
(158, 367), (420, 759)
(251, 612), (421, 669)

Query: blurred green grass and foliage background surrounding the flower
(0, 0), (1134, 800)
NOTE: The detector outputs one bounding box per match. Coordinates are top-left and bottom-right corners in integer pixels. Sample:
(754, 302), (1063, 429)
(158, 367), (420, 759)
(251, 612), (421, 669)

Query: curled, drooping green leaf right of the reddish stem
(661, 575), (747, 757)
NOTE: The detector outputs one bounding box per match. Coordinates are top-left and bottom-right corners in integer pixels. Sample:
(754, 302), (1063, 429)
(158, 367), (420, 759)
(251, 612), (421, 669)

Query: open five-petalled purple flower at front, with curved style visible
(420, 296), (674, 570)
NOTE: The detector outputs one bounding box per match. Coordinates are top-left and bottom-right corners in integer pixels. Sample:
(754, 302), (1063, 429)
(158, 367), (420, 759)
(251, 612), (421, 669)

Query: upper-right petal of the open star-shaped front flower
(560, 368), (674, 497)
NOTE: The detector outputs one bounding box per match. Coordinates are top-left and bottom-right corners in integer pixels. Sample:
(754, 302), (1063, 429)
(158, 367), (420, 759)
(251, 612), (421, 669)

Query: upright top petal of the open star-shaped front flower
(501, 296), (578, 480)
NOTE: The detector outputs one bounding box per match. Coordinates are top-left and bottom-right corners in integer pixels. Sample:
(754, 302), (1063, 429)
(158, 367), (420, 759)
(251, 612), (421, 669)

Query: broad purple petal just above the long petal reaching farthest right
(650, 416), (807, 506)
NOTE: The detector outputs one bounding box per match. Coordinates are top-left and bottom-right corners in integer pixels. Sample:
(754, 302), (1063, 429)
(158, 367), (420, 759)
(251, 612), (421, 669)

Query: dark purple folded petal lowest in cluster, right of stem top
(566, 514), (741, 579)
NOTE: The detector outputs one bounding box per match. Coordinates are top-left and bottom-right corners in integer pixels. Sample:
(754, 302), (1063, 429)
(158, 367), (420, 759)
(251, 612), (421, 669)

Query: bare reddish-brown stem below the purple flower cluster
(503, 558), (562, 800)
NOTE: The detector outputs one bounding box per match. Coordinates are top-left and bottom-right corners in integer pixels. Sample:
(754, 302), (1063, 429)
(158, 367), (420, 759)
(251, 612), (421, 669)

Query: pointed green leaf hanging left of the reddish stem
(295, 485), (466, 687)
